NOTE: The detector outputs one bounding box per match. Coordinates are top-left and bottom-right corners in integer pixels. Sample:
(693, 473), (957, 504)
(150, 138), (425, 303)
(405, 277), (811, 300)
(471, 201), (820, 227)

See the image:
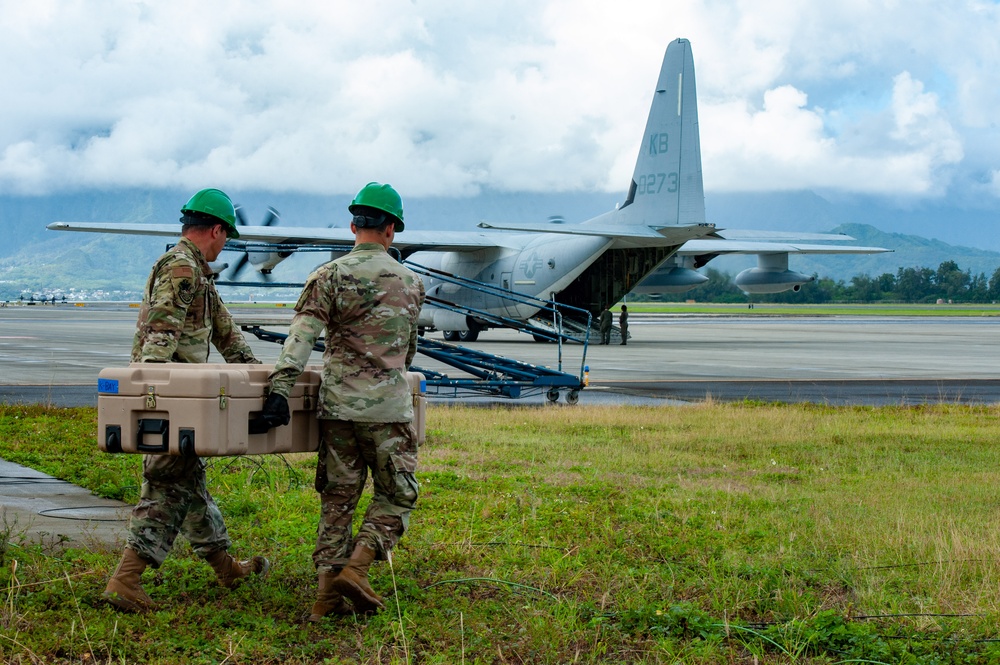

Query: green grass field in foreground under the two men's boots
(0, 402), (1000, 664)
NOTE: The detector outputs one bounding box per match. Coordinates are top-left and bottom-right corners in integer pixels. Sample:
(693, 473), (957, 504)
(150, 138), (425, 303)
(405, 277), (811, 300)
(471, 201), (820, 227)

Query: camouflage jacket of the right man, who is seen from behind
(270, 243), (424, 423)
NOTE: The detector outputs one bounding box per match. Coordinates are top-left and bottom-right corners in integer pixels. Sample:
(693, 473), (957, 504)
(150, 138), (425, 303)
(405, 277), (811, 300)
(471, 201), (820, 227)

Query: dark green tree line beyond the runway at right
(633, 261), (1000, 303)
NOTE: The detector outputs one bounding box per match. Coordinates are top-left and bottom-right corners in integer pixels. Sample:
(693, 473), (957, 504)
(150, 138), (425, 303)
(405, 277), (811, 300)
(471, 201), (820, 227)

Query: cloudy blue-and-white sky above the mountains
(0, 0), (1000, 206)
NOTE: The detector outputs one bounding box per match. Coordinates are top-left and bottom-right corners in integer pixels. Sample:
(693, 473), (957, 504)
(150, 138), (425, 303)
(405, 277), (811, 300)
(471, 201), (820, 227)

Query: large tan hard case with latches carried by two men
(97, 363), (426, 457)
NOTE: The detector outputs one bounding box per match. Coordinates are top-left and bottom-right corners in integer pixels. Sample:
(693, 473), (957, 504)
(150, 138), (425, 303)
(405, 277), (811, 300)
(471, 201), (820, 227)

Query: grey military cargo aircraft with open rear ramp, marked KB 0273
(48, 39), (889, 341)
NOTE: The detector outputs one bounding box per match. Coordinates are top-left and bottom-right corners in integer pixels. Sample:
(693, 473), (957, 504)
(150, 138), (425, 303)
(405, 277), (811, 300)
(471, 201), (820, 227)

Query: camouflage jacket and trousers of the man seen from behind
(270, 243), (424, 573)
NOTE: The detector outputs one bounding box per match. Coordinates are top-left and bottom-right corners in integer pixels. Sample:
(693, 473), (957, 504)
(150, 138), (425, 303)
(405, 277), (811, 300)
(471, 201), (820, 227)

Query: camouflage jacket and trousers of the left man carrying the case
(126, 238), (260, 567)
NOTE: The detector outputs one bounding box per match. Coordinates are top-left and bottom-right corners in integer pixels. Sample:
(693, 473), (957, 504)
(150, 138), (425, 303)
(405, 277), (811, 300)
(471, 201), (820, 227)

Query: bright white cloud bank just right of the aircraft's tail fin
(702, 72), (963, 196)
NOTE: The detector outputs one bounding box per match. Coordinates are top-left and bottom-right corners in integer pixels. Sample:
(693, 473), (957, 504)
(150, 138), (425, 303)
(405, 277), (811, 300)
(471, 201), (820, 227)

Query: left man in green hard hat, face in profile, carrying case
(104, 189), (268, 612)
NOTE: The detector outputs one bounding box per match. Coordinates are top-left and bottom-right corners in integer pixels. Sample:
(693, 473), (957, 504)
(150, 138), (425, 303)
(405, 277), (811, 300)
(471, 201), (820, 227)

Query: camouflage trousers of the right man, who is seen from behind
(313, 420), (418, 573)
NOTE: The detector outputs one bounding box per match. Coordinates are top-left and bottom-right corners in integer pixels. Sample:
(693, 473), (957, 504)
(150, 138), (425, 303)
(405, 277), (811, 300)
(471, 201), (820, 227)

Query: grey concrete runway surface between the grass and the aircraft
(0, 305), (1000, 406)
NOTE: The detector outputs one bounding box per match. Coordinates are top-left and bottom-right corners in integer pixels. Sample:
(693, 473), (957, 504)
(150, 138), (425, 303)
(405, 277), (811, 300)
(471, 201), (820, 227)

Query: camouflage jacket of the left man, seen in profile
(132, 238), (259, 363)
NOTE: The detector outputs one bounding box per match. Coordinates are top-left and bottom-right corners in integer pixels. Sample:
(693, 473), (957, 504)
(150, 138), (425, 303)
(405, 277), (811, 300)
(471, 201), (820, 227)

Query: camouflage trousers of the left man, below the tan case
(125, 455), (231, 567)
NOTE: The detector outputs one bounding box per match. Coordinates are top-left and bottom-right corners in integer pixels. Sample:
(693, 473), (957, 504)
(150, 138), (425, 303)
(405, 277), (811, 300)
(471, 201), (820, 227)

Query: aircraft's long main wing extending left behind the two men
(47, 222), (520, 253)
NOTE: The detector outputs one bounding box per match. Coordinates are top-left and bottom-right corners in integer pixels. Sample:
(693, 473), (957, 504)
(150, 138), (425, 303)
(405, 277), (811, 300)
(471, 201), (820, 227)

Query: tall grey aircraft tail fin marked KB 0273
(619, 39), (705, 227)
